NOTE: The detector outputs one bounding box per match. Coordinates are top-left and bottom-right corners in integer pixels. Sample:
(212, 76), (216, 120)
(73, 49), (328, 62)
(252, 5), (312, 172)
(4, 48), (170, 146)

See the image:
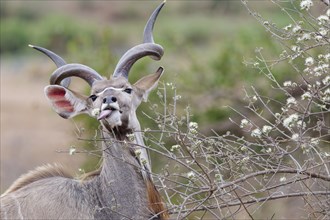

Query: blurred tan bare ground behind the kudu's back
(0, 58), (84, 193)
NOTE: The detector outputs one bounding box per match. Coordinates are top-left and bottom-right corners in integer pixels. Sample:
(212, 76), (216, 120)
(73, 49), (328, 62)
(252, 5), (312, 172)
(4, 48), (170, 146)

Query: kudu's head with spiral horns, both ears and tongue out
(30, 3), (164, 137)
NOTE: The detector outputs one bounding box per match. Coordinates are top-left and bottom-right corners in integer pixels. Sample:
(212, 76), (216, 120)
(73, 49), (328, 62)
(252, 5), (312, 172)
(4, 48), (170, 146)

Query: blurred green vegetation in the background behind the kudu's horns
(0, 1), (300, 170)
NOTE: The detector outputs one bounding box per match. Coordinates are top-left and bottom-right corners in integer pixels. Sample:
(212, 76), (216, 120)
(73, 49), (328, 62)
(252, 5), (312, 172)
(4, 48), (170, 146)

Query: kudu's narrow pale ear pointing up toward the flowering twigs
(134, 67), (164, 102)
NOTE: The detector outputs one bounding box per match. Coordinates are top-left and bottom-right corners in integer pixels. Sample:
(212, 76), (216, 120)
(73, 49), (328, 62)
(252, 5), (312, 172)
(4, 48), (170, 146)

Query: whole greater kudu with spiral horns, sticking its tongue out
(1, 3), (167, 219)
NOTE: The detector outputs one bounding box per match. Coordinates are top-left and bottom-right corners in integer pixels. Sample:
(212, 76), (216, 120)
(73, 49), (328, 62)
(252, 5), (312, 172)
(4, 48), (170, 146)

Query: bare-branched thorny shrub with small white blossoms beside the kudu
(143, 0), (330, 219)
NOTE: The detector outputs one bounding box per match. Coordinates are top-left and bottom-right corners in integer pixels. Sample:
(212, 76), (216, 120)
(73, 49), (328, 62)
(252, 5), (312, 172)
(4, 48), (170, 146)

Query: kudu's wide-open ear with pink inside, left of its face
(45, 85), (87, 118)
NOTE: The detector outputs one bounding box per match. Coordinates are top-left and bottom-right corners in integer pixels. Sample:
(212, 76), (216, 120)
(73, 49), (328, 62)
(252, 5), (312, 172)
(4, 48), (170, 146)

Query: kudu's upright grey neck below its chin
(95, 124), (148, 219)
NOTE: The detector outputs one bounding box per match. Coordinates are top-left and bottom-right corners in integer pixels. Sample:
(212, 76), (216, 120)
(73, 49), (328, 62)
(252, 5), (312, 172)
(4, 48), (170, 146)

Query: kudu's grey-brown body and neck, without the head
(1, 131), (152, 219)
